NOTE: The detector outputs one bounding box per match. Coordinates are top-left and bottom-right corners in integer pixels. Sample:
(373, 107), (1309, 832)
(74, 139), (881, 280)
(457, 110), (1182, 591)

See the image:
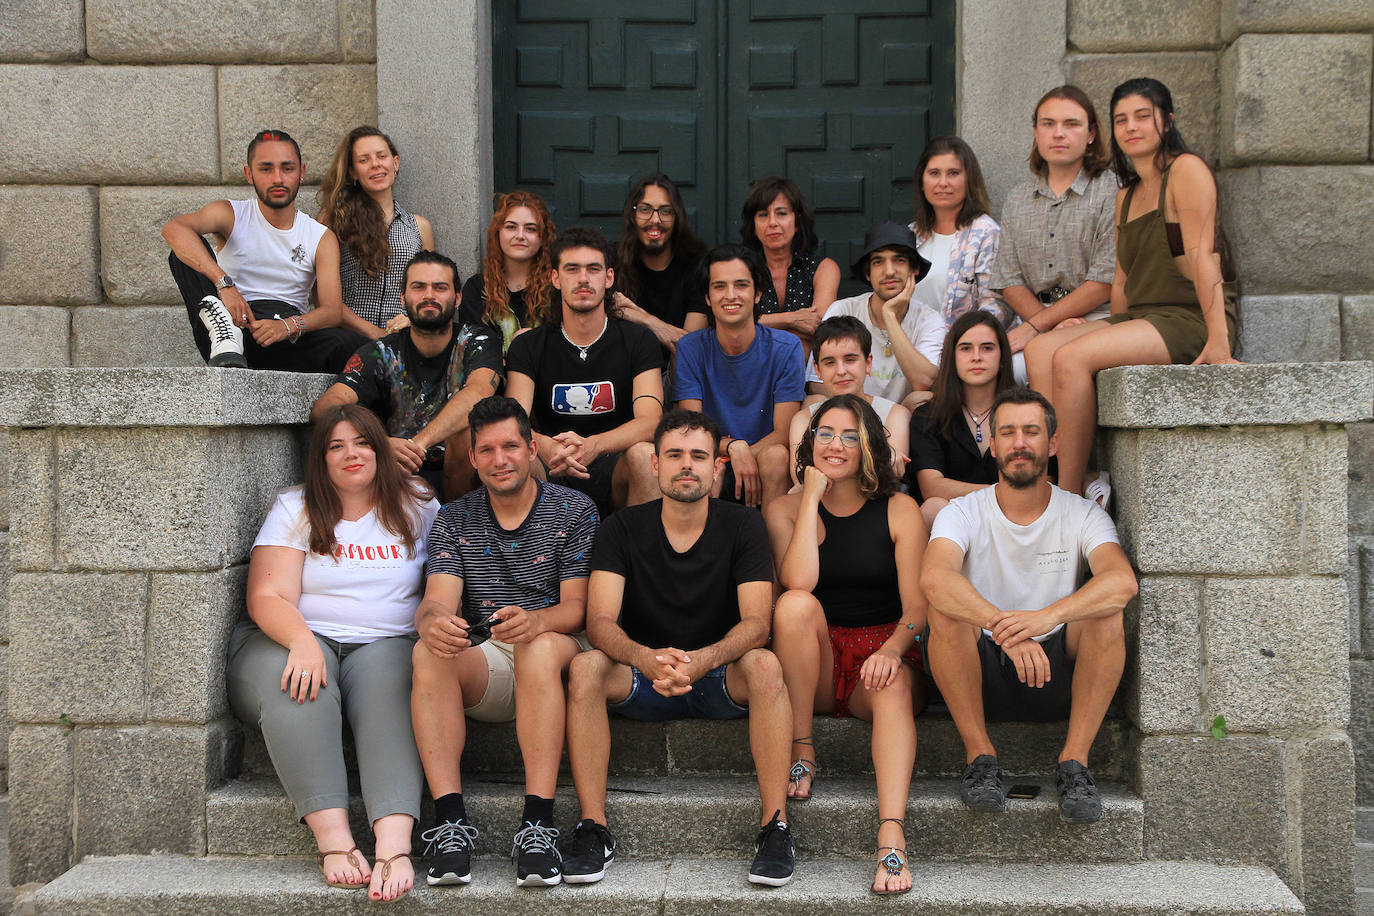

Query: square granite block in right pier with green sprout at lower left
(1202, 578), (1351, 732)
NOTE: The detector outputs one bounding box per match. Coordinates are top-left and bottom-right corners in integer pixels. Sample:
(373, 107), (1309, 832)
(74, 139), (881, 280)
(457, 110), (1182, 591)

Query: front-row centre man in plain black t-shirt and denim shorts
(563, 409), (794, 886)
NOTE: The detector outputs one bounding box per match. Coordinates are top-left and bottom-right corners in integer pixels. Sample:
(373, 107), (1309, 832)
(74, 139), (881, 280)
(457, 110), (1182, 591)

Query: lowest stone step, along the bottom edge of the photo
(30, 856), (1304, 916)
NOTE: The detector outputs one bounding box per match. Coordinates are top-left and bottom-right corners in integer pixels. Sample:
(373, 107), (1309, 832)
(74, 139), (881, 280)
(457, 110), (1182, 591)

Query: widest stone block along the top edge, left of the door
(85, 0), (339, 63)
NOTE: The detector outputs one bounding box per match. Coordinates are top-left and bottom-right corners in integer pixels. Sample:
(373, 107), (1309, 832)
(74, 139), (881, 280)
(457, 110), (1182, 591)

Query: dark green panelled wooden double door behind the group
(493, 0), (954, 289)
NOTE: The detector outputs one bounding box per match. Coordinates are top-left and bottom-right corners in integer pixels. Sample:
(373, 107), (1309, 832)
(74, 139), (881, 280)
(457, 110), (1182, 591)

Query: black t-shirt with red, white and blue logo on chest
(506, 319), (664, 437)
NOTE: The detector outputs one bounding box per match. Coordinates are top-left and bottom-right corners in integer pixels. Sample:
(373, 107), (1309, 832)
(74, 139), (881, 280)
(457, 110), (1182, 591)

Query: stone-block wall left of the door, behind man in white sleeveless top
(0, 0), (376, 368)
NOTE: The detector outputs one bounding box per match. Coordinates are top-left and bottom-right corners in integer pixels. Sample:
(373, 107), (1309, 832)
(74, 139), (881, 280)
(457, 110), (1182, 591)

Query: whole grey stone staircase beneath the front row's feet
(29, 710), (1304, 916)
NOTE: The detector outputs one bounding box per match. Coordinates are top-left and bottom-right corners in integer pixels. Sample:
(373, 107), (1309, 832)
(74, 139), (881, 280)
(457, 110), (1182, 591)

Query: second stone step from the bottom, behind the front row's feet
(206, 776), (1145, 862)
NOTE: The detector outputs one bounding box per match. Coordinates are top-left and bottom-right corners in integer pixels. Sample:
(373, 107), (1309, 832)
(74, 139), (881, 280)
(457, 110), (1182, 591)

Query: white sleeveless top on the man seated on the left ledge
(217, 199), (328, 312)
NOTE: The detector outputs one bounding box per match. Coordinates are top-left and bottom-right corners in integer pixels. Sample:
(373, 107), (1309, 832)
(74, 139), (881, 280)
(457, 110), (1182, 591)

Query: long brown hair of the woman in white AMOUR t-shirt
(304, 404), (429, 556)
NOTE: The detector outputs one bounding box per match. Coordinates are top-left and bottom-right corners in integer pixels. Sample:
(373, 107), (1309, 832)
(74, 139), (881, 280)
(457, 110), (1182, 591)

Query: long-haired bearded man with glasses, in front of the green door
(614, 172), (706, 352)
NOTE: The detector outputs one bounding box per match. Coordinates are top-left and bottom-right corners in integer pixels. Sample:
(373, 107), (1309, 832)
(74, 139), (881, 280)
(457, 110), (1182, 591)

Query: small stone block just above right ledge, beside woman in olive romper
(1239, 295), (1341, 363)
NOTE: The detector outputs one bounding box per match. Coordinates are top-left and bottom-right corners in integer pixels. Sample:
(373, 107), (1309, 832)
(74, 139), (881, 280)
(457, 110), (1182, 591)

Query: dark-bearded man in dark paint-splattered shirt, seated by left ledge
(311, 250), (502, 500)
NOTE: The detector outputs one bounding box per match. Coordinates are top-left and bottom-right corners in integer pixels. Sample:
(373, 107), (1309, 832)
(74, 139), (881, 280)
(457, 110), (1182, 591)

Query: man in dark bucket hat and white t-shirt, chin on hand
(807, 222), (945, 409)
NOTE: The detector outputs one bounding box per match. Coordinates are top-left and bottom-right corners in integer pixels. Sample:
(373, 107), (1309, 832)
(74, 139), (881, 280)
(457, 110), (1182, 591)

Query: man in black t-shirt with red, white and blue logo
(506, 227), (664, 516)
